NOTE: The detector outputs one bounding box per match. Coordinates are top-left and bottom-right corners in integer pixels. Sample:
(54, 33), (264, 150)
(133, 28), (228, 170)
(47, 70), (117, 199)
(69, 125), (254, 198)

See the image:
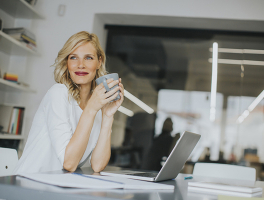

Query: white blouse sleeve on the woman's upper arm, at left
(45, 84), (73, 166)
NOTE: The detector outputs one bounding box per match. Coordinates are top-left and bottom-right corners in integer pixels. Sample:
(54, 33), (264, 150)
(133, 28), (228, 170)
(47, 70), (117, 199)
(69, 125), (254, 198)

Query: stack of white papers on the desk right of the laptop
(188, 182), (262, 197)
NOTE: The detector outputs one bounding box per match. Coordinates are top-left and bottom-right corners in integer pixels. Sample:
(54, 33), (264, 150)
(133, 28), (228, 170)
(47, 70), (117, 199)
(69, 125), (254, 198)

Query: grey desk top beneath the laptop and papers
(0, 166), (264, 200)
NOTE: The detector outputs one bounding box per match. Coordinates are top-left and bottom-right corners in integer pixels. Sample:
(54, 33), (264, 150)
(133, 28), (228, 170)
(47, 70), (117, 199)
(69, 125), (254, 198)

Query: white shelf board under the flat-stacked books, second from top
(0, 31), (39, 56)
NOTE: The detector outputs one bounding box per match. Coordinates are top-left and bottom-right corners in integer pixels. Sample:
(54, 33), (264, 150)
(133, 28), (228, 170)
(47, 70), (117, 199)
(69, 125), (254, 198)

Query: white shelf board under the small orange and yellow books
(0, 78), (36, 93)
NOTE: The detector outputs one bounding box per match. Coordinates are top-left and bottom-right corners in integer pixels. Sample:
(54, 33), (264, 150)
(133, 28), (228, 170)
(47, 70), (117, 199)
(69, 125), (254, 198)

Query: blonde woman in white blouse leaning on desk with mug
(14, 31), (124, 174)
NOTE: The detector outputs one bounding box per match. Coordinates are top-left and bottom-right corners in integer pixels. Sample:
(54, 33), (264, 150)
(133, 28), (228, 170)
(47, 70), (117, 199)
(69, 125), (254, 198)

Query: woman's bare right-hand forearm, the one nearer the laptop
(91, 116), (114, 172)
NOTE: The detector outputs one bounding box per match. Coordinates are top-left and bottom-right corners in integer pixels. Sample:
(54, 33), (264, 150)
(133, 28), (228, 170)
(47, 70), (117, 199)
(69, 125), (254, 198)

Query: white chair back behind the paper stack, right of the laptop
(193, 163), (256, 181)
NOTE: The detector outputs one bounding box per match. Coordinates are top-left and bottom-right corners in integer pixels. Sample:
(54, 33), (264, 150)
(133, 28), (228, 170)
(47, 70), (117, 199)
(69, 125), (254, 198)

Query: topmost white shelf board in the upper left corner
(0, 0), (45, 19)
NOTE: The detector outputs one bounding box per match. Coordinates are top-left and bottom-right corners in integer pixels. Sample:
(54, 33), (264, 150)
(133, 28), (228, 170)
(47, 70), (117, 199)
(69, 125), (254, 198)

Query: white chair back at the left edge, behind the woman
(0, 147), (18, 176)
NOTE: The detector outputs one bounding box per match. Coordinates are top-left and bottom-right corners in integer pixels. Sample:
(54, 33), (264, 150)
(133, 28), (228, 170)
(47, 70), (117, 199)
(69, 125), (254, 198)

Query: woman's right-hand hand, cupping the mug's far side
(102, 78), (124, 117)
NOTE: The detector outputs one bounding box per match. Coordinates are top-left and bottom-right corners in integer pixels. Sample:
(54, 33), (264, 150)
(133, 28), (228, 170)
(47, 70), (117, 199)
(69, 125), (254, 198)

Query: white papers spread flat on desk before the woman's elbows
(18, 173), (174, 190)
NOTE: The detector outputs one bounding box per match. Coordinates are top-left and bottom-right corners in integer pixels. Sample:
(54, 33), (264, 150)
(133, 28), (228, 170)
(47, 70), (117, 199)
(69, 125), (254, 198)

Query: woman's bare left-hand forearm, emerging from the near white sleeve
(63, 109), (97, 171)
